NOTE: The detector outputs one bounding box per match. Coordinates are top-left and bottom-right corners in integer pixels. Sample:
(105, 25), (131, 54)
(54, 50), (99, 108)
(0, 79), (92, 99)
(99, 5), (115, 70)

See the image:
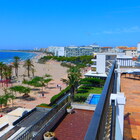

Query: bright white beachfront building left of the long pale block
(47, 46), (64, 56)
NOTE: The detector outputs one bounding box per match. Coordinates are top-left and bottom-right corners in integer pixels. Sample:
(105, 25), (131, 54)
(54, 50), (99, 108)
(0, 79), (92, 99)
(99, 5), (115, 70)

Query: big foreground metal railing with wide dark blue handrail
(85, 62), (116, 140)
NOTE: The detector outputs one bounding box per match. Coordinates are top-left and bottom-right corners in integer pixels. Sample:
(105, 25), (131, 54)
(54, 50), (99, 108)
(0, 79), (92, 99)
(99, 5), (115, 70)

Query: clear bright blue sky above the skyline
(0, 0), (140, 49)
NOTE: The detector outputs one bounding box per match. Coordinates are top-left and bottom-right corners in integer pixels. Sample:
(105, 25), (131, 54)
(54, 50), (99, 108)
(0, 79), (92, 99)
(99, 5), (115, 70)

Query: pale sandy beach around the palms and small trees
(0, 54), (67, 109)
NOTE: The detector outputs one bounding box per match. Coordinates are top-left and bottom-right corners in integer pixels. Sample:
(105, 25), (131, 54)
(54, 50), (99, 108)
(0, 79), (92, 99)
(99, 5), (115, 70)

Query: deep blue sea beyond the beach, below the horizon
(0, 51), (37, 63)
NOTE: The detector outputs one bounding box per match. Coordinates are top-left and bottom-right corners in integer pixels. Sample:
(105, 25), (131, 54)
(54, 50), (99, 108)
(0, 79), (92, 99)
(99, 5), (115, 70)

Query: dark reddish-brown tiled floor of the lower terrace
(54, 109), (93, 140)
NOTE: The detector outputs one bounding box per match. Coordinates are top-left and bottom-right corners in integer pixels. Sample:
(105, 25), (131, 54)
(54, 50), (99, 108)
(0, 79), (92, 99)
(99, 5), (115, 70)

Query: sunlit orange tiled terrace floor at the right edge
(121, 75), (140, 140)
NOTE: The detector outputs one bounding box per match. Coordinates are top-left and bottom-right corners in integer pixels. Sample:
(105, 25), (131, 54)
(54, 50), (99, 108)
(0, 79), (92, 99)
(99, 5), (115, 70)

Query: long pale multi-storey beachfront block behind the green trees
(65, 45), (100, 57)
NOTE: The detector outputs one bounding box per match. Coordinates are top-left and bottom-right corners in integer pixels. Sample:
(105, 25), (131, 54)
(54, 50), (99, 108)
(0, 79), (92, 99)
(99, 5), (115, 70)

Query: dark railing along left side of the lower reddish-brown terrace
(14, 94), (71, 140)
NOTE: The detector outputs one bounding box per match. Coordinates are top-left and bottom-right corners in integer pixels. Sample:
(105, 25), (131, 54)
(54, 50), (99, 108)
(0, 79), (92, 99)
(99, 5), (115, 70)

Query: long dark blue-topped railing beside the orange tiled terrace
(85, 62), (116, 140)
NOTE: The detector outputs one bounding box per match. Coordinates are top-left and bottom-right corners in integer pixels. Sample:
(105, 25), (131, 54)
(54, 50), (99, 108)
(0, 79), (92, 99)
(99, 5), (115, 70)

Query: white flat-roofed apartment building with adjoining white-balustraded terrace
(85, 53), (136, 79)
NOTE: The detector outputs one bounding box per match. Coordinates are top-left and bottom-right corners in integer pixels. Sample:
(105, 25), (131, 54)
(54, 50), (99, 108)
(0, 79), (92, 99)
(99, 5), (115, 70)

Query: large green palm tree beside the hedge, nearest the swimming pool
(61, 66), (81, 99)
